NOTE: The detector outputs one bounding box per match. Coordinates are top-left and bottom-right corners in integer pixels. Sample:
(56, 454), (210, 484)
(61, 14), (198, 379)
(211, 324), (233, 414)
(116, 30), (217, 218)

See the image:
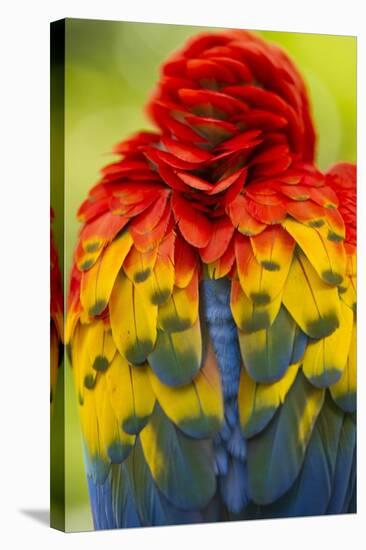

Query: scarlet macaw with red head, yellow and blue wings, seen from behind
(65, 30), (356, 529)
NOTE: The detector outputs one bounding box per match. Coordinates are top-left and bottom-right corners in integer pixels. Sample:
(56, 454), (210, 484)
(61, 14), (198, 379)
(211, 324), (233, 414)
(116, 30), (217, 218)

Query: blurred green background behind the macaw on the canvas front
(50, 19), (356, 531)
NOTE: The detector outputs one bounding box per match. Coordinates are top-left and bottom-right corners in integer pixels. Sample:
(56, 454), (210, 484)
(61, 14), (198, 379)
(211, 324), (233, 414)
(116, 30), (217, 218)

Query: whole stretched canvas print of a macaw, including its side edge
(50, 19), (356, 531)
